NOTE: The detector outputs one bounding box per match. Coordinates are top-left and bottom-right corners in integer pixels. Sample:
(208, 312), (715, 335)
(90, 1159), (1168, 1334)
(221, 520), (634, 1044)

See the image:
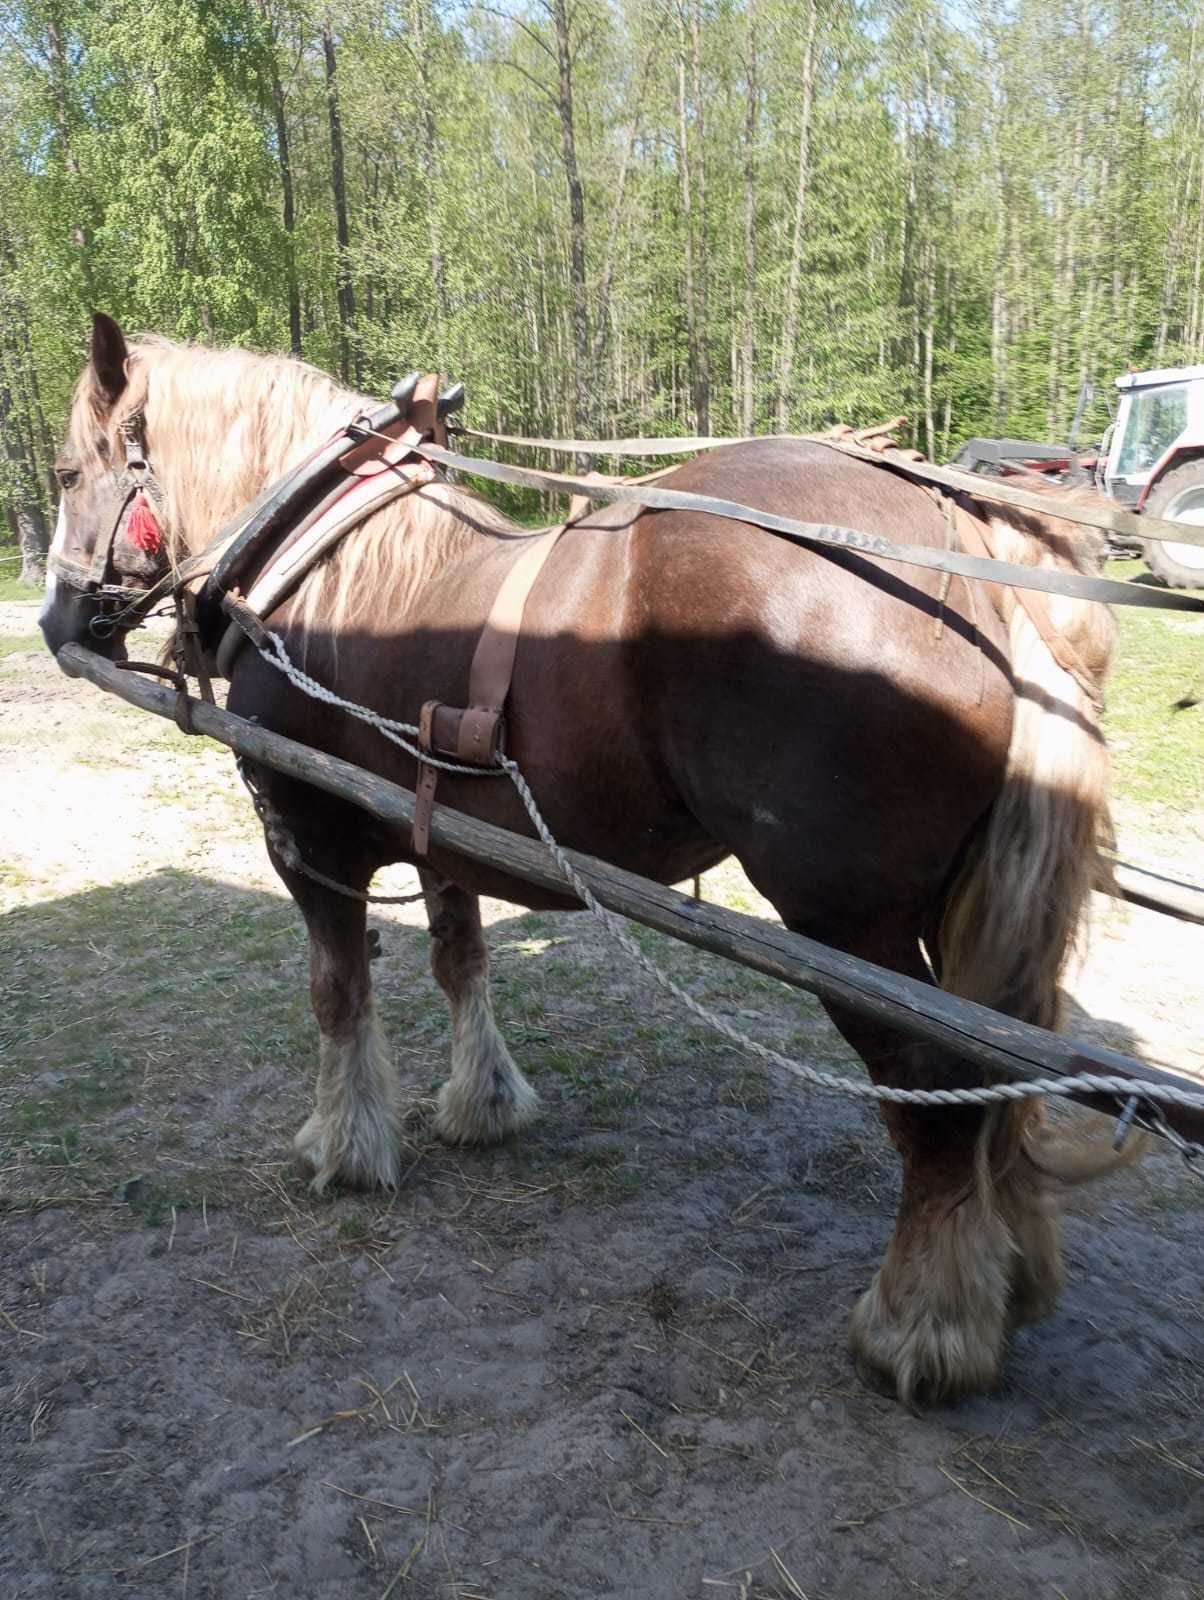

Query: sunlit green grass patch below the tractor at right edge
(1105, 562), (1204, 822)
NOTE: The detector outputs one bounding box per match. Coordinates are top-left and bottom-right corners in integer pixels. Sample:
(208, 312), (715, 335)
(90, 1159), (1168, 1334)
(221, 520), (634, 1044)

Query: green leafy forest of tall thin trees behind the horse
(0, 0), (1204, 576)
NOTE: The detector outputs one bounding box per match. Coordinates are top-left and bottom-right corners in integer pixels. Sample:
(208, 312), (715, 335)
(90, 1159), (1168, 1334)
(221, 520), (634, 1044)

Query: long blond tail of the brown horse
(937, 588), (1140, 1182)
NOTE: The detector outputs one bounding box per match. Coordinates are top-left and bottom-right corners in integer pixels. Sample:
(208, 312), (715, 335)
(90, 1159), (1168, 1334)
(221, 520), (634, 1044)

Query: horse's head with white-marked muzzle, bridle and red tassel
(38, 312), (170, 659)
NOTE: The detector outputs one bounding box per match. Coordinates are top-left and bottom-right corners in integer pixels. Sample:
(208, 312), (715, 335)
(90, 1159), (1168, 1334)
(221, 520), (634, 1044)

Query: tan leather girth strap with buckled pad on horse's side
(410, 522), (570, 856)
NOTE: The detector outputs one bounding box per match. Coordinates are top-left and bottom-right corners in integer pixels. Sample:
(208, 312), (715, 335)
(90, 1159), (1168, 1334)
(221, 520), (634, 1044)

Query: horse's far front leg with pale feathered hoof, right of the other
(421, 872), (540, 1144)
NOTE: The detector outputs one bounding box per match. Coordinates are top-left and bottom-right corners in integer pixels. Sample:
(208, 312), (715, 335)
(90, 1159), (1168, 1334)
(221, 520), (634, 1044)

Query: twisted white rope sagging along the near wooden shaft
(249, 620), (1204, 1157)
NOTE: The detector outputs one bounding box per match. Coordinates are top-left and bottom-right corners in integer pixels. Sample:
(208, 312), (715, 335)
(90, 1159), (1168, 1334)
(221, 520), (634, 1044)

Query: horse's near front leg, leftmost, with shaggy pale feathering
(269, 842), (400, 1192)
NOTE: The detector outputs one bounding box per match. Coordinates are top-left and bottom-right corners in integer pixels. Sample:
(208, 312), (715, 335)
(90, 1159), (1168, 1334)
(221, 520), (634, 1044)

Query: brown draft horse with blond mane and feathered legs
(42, 315), (1113, 1405)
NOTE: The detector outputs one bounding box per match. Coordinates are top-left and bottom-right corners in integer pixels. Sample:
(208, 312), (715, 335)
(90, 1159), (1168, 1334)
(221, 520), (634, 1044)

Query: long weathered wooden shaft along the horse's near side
(58, 645), (1204, 1141)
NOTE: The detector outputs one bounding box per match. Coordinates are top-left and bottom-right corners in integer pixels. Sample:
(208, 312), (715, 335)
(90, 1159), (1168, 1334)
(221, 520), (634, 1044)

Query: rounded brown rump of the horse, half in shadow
(553, 440), (1012, 938)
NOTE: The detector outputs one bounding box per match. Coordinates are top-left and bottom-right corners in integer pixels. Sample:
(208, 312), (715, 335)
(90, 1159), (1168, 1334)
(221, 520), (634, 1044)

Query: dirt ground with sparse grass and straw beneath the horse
(0, 606), (1204, 1600)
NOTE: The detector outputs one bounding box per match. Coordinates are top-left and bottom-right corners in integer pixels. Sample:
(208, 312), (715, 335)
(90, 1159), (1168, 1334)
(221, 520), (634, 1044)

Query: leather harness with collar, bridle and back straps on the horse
(50, 385), (1122, 856)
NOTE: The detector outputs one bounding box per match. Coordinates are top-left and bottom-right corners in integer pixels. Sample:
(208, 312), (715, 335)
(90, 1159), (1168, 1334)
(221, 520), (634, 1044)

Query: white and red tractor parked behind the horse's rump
(953, 366), (1204, 589)
